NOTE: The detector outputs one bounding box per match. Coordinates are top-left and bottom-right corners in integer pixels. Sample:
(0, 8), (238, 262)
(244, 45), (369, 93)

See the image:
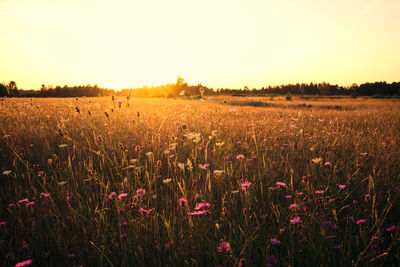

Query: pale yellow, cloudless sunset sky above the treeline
(0, 0), (400, 89)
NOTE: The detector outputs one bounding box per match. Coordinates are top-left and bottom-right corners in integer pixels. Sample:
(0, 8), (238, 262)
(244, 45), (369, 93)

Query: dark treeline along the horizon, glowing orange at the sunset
(0, 79), (400, 98)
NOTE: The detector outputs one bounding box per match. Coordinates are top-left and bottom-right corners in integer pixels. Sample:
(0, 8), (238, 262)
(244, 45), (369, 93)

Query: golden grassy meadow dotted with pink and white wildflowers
(0, 97), (400, 266)
